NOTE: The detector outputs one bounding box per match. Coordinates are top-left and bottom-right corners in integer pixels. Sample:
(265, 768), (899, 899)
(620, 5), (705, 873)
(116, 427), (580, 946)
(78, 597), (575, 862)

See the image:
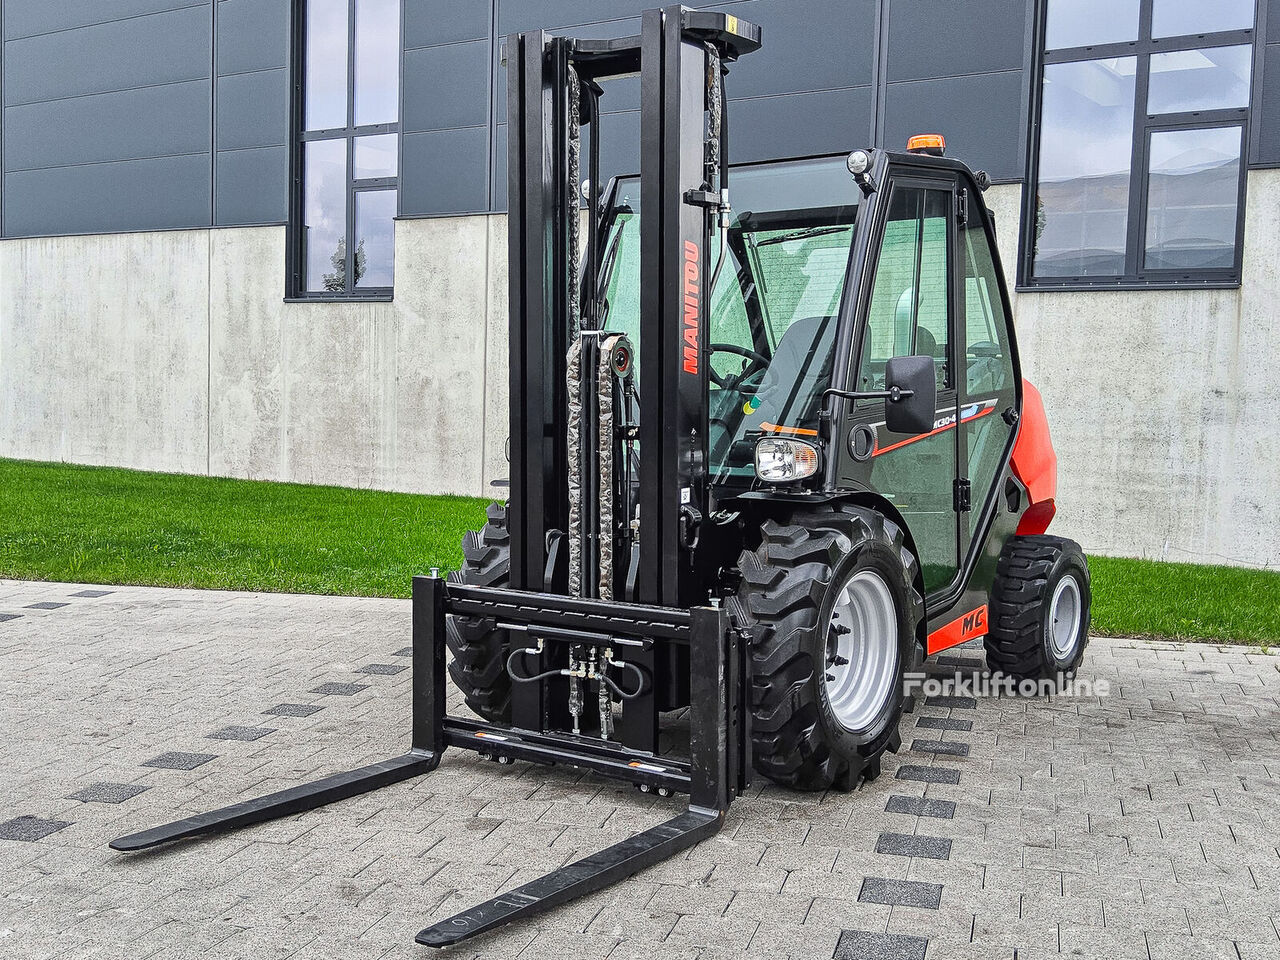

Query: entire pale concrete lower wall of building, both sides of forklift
(0, 179), (1280, 566)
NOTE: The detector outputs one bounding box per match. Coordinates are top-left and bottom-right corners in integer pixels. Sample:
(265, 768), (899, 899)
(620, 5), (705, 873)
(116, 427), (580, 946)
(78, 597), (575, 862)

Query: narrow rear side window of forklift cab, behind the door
(964, 224), (1014, 397)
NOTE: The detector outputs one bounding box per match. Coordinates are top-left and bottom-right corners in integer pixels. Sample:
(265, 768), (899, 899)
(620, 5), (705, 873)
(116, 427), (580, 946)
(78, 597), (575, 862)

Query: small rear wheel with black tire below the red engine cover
(986, 536), (1092, 682)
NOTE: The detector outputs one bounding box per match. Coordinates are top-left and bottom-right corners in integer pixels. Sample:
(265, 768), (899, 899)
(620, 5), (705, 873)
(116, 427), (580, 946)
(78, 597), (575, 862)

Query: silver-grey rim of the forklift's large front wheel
(824, 570), (899, 732)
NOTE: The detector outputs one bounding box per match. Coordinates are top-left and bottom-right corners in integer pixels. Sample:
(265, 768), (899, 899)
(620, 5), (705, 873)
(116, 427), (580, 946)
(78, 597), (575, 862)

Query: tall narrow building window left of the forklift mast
(288, 0), (401, 300)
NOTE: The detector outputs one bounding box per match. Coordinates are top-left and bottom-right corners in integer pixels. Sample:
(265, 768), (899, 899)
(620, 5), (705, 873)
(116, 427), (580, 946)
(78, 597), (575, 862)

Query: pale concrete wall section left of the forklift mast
(0, 216), (507, 494)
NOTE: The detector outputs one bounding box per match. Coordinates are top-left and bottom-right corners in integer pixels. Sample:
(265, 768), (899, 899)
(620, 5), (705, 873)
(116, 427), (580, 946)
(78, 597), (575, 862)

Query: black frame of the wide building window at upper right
(1018, 0), (1266, 292)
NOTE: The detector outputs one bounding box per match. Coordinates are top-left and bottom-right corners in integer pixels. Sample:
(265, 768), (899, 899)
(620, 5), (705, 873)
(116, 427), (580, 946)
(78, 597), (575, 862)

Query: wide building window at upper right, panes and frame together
(1021, 0), (1254, 288)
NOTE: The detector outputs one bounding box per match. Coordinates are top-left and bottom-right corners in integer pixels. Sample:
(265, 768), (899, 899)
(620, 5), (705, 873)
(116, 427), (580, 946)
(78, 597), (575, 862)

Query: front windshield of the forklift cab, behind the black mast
(602, 159), (861, 485)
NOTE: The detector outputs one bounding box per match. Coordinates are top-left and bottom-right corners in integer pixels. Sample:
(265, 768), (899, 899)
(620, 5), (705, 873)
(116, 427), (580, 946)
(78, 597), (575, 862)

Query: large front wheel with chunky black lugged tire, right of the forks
(731, 504), (924, 790)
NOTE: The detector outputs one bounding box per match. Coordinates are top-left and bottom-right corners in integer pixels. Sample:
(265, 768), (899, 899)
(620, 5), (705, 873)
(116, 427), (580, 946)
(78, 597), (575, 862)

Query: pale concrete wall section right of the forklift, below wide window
(987, 170), (1280, 567)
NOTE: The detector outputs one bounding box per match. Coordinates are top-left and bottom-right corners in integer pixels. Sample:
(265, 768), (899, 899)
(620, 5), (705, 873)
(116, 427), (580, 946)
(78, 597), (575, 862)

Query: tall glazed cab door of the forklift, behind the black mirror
(842, 175), (961, 594)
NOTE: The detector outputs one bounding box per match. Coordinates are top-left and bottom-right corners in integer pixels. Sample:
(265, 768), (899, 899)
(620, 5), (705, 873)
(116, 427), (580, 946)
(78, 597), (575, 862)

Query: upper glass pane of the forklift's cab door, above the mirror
(858, 187), (952, 390)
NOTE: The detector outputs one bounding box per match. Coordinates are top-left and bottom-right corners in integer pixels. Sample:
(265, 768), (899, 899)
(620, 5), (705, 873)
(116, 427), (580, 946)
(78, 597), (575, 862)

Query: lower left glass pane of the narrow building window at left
(302, 140), (347, 293)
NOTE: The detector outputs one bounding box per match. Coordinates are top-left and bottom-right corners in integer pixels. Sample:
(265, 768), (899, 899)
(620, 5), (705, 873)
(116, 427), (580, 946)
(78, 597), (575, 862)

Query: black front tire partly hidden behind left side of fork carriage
(444, 503), (511, 723)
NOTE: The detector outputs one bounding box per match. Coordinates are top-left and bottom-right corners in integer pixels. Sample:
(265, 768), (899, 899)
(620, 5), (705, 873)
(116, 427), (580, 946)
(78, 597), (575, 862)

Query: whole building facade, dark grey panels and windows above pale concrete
(0, 0), (1280, 566)
